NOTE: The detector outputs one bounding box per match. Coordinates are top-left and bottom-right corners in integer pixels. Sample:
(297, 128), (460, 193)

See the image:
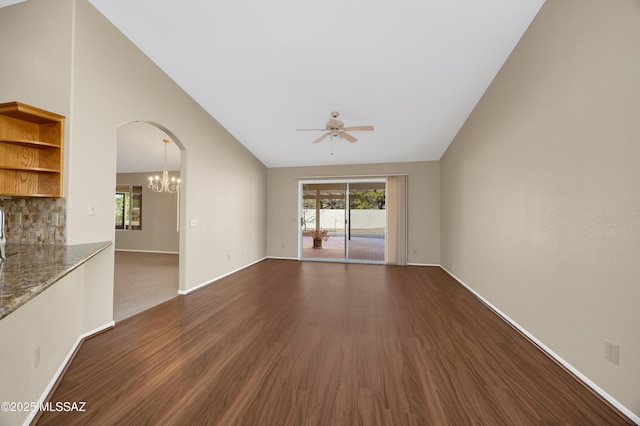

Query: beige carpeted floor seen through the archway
(113, 251), (179, 322)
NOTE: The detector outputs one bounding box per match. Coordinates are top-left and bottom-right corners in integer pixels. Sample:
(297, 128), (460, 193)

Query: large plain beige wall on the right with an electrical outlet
(440, 0), (640, 415)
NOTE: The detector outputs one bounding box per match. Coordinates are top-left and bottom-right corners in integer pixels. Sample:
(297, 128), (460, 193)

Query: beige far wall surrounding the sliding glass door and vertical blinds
(267, 161), (440, 265)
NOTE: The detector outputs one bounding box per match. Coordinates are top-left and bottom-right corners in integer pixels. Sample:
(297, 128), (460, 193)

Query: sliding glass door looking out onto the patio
(300, 179), (386, 263)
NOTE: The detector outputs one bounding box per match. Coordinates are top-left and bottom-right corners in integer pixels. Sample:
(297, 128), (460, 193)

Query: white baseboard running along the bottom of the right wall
(439, 265), (640, 425)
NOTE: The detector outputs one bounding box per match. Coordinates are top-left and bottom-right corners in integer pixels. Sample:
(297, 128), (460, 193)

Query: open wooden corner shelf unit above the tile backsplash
(0, 102), (64, 197)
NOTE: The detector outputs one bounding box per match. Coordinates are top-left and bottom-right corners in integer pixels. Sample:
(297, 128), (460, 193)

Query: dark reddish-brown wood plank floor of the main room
(38, 260), (631, 425)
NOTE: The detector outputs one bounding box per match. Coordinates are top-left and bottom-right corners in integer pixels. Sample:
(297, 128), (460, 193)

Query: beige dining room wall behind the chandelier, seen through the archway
(115, 172), (180, 253)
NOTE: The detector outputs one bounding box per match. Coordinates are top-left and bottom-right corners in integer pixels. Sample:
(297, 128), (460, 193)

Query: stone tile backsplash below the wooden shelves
(0, 198), (67, 244)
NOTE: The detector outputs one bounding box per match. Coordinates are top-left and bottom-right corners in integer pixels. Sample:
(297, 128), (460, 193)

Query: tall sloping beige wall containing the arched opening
(68, 0), (266, 291)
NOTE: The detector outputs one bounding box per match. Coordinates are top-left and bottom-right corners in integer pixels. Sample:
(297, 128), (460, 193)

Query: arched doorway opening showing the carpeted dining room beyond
(113, 121), (182, 322)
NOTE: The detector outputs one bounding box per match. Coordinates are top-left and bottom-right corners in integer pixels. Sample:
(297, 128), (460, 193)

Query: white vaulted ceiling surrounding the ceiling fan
(99, 0), (544, 169)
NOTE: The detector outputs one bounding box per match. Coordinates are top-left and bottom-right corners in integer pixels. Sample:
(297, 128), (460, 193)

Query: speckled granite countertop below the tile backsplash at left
(0, 241), (111, 319)
